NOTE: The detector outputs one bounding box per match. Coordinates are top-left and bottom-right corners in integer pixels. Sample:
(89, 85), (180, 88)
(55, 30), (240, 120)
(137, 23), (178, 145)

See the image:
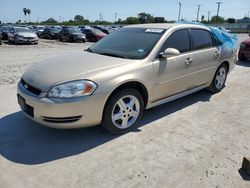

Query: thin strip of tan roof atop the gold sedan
(125, 23), (209, 30)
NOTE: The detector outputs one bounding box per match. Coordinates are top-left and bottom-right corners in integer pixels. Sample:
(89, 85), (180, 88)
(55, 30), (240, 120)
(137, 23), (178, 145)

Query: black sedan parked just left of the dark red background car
(59, 27), (87, 42)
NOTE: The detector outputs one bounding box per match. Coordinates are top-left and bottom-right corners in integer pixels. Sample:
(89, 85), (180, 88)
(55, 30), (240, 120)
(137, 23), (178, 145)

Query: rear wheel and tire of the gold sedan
(208, 63), (228, 93)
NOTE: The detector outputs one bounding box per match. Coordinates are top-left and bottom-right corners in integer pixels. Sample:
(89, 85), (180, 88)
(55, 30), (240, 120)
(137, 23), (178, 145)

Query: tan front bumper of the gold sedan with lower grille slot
(17, 82), (107, 129)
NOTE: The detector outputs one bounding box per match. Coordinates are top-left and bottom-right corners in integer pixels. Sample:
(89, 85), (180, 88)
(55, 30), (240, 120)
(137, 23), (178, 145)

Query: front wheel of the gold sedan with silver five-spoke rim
(102, 88), (144, 134)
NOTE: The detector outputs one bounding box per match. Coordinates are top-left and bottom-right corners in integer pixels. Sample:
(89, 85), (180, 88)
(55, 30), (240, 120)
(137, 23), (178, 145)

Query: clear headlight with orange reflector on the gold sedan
(48, 80), (97, 98)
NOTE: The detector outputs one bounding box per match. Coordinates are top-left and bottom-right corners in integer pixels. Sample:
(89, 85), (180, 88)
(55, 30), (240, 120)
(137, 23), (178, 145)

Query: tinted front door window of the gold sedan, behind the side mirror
(161, 29), (190, 53)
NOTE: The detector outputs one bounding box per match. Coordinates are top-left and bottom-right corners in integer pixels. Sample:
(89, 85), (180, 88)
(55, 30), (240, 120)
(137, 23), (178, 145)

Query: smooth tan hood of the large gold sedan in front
(23, 52), (133, 91)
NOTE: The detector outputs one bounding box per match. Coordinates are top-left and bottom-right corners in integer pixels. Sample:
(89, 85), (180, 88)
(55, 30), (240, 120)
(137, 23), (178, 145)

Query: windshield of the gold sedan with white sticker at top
(87, 28), (166, 59)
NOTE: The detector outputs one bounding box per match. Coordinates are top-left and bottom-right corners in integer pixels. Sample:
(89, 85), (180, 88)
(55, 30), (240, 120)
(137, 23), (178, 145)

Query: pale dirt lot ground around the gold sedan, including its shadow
(0, 34), (250, 188)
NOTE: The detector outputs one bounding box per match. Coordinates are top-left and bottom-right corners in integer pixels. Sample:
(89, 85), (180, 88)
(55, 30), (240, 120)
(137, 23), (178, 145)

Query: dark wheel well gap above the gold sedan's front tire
(105, 81), (148, 107)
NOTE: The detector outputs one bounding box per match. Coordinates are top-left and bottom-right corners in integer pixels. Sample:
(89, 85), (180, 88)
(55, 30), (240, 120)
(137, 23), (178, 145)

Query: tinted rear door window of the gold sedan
(191, 29), (213, 50)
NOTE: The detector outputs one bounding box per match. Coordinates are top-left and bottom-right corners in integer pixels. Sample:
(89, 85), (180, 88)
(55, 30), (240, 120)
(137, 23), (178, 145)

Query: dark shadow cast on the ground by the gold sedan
(0, 91), (212, 165)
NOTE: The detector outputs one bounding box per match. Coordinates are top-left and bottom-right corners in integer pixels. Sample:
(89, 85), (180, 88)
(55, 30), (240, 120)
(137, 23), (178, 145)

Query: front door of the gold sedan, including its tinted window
(152, 29), (194, 101)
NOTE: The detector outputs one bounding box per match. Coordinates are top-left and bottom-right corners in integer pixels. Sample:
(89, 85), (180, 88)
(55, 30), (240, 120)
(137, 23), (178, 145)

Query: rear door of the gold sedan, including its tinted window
(190, 29), (220, 87)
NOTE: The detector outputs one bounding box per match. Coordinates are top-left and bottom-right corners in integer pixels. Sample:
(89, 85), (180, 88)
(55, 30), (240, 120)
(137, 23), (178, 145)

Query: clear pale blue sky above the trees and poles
(0, 0), (250, 23)
